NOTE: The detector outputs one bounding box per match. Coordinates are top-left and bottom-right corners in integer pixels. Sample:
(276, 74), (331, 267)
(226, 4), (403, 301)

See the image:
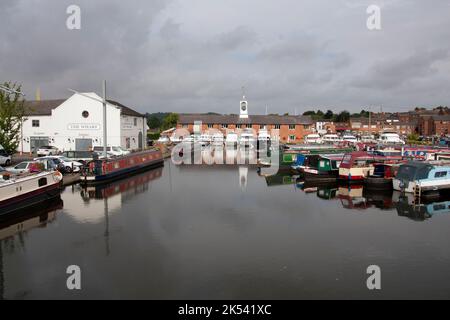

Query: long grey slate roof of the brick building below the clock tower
(178, 113), (314, 125)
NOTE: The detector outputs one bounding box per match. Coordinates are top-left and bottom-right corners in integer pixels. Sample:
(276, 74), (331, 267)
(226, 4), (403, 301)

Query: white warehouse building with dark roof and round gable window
(18, 93), (148, 152)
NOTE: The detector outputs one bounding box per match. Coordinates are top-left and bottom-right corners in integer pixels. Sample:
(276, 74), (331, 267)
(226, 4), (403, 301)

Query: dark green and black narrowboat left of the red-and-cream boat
(303, 155), (343, 181)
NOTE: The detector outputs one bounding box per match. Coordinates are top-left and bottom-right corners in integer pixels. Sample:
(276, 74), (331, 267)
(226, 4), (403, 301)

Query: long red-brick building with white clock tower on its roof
(177, 97), (315, 143)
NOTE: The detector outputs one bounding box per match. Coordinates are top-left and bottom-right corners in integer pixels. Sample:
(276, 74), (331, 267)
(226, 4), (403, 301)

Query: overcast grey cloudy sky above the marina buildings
(0, 0), (450, 114)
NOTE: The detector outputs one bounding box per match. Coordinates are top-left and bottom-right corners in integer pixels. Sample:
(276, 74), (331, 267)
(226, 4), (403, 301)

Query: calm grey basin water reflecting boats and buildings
(0, 161), (450, 299)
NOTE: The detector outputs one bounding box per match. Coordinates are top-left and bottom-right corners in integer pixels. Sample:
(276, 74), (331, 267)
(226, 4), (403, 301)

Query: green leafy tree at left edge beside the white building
(0, 82), (26, 154)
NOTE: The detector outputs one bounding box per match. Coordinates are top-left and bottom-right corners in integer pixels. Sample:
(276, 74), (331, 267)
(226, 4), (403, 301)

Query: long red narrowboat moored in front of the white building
(81, 150), (164, 185)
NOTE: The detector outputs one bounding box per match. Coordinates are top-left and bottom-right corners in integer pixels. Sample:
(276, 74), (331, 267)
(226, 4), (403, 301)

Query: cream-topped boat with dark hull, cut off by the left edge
(0, 171), (63, 215)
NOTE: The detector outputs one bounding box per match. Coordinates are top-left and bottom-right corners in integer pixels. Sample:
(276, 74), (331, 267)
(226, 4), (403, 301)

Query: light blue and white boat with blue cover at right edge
(392, 161), (450, 197)
